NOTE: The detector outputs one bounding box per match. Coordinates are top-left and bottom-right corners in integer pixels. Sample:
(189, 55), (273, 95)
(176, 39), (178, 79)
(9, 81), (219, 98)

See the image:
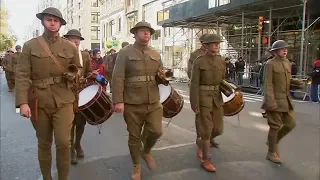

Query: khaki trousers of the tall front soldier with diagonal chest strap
(33, 104), (74, 180)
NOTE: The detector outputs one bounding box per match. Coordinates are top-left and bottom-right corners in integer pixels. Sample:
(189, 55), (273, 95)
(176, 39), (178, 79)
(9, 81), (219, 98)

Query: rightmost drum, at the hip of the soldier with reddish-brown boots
(221, 86), (245, 116)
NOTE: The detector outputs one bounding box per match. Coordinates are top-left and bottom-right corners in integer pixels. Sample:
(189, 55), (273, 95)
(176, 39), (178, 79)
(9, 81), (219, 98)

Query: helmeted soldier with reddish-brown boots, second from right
(190, 34), (226, 172)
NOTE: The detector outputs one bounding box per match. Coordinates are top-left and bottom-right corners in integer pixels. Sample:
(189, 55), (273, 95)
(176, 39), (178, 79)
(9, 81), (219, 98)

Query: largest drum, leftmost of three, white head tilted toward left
(78, 84), (113, 125)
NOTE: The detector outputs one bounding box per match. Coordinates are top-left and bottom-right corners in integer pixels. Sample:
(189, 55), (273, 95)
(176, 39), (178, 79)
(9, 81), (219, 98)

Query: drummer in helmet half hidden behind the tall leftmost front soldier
(64, 29), (96, 164)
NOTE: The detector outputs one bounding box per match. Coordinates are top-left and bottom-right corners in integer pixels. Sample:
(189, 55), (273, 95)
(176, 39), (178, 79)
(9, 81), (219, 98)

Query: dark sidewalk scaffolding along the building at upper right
(161, 0), (320, 79)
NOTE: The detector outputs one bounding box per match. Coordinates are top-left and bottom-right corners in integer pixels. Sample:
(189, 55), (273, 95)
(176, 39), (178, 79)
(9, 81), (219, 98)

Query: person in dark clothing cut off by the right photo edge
(310, 51), (320, 103)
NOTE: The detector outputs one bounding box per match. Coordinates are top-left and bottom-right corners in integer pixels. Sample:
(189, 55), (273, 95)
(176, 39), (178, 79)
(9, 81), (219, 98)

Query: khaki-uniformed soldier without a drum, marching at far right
(262, 40), (296, 163)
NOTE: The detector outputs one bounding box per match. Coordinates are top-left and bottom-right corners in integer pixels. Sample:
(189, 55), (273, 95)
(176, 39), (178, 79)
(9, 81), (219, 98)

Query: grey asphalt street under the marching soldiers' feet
(0, 69), (320, 180)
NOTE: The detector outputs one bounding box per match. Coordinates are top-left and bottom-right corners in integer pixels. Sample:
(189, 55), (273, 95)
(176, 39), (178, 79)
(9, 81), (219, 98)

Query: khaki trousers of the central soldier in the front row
(123, 102), (163, 164)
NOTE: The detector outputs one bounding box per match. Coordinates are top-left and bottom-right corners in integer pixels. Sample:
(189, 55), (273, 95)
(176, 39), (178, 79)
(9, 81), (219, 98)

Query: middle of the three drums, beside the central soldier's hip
(158, 84), (184, 118)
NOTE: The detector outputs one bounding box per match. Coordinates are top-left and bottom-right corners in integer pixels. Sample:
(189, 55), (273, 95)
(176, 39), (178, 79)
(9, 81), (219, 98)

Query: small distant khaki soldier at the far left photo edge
(2, 49), (15, 92)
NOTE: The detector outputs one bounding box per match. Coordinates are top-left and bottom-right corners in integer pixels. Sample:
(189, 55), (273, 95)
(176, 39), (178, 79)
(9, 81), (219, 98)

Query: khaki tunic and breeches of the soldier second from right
(190, 53), (226, 140)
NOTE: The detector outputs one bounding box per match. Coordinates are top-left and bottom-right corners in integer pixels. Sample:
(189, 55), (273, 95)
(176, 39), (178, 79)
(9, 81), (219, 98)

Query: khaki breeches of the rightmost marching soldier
(267, 110), (296, 152)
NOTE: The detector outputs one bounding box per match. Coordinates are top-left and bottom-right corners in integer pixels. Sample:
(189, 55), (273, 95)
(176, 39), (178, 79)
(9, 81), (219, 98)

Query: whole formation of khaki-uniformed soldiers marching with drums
(3, 7), (304, 180)
